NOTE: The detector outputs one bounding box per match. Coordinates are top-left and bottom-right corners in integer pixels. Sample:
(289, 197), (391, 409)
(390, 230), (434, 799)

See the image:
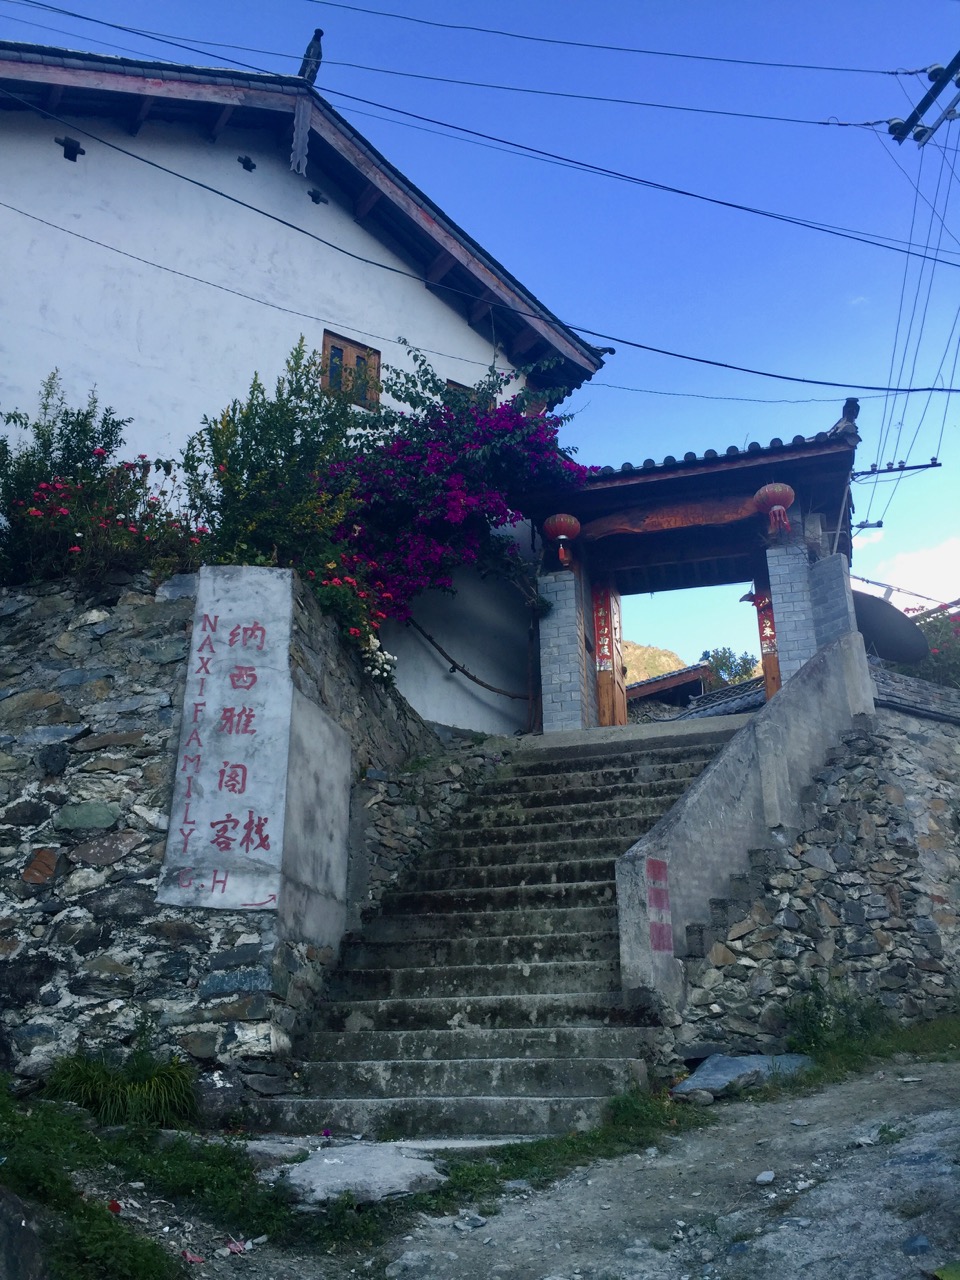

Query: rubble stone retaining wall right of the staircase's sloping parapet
(677, 709), (960, 1056)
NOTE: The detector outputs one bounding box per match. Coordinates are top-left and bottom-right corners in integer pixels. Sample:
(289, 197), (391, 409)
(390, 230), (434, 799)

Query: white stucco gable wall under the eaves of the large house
(0, 111), (512, 457)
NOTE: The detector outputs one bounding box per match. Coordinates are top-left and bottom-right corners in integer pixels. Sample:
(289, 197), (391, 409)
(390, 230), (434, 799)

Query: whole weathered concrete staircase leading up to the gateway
(271, 722), (731, 1137)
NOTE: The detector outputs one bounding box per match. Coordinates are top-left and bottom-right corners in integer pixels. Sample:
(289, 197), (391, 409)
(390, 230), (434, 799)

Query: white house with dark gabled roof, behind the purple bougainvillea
(0, 42), (602, 731)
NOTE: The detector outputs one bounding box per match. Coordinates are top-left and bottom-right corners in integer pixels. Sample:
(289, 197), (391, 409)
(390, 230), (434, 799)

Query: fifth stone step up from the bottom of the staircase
(326, 956), (620, 1001)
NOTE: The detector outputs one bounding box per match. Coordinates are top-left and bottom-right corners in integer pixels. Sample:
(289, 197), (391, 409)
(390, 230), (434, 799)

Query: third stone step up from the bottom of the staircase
(297, 1027), (659, 1062)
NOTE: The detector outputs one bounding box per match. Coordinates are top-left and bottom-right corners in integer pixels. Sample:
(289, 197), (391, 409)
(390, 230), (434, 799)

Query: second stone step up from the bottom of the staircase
(300, 1057), (631, 1098)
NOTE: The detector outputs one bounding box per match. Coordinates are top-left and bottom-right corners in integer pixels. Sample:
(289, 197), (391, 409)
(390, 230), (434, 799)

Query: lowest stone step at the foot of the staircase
(251, 1096), (609, 1139)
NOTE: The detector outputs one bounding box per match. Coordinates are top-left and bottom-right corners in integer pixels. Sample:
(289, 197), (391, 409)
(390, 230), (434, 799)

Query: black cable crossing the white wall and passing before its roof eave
(0, 87), (960, 394)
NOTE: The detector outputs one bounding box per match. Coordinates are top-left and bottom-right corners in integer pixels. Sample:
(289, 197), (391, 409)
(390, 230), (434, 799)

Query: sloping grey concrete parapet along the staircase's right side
(617, 632), (874, 1007)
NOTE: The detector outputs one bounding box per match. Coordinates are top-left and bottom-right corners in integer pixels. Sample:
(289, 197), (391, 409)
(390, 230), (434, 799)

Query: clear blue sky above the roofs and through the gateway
(0, 0), (960, 660)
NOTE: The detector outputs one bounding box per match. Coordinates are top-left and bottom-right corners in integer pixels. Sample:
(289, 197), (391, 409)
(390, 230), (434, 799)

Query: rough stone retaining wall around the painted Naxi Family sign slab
(0, 577), (504, 1092)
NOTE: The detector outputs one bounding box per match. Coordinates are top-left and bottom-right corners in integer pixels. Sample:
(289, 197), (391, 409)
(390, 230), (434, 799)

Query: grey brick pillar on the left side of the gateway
(540, 570), (595, 733)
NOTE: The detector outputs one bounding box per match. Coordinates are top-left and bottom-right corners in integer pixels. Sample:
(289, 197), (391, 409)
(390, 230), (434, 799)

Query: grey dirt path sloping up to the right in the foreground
(86, 1062), (960, 1280)
